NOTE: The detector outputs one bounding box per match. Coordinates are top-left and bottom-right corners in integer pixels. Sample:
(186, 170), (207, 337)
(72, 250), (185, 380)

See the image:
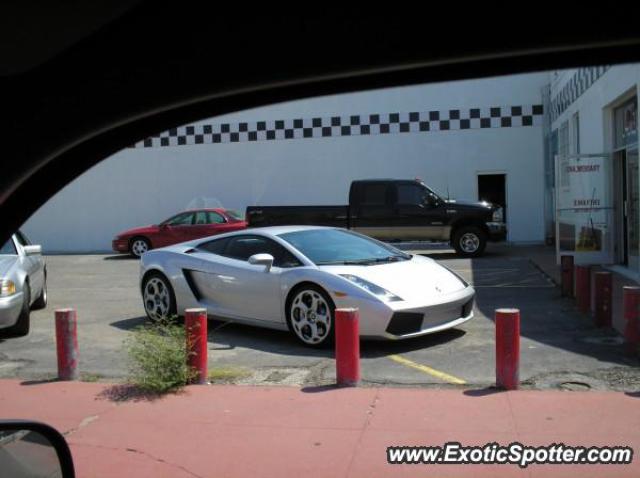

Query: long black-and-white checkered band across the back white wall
(134, 105), (543, 148)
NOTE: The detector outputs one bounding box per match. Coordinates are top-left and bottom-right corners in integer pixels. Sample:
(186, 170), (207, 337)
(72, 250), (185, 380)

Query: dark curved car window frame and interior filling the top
(0, 0), (640, 242)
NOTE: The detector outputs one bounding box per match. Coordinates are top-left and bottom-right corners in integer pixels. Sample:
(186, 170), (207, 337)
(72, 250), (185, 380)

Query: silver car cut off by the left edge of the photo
(0, 231), (47, 338)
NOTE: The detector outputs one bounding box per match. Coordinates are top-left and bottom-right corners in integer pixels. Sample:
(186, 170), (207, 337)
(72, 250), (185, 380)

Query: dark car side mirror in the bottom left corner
(0, 420), (75, 478)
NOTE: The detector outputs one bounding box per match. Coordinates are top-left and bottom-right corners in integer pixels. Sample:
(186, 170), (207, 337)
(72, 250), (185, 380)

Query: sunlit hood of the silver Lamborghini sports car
(319, 256), (466, 301)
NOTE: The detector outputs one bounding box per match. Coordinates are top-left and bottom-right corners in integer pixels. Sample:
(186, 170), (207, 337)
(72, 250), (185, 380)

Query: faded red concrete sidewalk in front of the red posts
(0, 380), (640, 478)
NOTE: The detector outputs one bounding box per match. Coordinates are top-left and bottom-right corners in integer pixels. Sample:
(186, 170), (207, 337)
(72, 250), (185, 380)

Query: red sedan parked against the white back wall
(112, 208), (247, 257)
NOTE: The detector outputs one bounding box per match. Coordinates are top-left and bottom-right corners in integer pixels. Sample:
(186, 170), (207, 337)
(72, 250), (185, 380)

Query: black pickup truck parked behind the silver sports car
(246, 179), (507, 257)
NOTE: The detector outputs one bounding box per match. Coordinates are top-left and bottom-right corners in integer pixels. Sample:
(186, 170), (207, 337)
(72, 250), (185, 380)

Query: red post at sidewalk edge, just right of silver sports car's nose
(495, 309), (520, 390)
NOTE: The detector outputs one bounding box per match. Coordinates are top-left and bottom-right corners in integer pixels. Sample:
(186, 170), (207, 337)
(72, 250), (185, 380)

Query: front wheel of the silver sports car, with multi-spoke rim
(287, 284), (336, 347)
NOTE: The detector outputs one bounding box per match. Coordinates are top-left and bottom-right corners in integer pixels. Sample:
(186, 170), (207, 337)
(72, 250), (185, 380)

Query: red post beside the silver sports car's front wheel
(335, 309), (360, 387)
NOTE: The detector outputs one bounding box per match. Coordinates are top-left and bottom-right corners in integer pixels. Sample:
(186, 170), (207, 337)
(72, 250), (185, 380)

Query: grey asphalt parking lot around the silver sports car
(0, 248), (640, 390)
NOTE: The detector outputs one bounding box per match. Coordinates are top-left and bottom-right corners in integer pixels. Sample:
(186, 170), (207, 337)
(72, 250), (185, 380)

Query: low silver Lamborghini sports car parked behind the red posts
(140, 226), (475, 346)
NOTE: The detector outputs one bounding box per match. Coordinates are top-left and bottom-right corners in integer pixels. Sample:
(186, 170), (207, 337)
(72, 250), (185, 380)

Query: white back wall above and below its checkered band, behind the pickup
(23, 73), (548, 252)
